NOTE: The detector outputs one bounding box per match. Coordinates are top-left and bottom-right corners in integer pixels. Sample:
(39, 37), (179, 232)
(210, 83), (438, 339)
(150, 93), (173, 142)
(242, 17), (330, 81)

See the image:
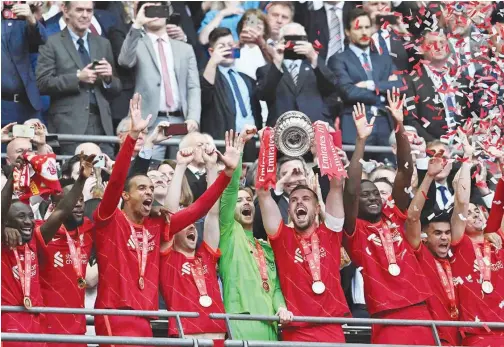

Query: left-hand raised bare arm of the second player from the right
(406, 153), (446, 249)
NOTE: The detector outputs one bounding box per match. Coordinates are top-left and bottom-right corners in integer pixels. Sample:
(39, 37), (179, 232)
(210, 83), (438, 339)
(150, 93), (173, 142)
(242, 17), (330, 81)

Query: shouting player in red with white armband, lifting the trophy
(257, 130), (350, 342)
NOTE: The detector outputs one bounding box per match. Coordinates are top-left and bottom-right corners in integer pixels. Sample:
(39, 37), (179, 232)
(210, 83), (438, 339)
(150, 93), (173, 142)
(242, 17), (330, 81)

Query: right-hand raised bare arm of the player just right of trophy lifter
(387, 88), (413, 211)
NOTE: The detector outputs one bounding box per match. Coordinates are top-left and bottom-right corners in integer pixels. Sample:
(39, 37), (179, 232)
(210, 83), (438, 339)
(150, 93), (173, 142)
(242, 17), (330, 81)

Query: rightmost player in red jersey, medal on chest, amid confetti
(452, 142), (504, 347)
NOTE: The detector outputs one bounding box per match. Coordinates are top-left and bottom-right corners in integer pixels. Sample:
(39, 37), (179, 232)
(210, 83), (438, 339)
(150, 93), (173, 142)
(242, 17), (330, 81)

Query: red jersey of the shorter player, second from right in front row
(415, 244), (460, 346)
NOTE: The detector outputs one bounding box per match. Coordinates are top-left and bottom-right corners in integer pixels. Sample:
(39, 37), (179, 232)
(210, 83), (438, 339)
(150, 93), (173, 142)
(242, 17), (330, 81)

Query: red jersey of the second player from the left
(35, 218), (94, 334)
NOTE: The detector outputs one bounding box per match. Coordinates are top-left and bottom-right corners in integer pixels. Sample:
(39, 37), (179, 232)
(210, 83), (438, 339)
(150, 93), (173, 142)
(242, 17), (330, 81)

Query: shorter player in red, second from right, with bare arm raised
(406, 153), (462, 346)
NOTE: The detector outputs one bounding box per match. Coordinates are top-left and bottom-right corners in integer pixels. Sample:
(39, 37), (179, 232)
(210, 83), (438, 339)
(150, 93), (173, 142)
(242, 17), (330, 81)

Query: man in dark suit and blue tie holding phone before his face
(201, 28), (262, 161)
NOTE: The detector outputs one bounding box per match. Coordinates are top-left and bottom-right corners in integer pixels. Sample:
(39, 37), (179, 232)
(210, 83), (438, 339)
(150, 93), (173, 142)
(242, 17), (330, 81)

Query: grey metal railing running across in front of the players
(1, 306), (504, 347)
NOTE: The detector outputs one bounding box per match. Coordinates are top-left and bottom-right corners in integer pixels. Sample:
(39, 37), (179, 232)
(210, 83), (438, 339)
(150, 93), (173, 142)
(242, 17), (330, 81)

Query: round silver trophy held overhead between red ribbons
(275, 111), (315, 157)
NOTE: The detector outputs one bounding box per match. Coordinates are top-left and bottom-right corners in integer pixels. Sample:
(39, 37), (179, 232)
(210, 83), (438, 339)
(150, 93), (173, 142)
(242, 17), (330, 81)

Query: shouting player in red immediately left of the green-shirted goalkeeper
(160, 130), (244, 347)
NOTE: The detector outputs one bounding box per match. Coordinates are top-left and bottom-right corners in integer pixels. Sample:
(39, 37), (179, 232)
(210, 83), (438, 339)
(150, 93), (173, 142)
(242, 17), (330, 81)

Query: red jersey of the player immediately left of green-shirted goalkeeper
(160, 242), (226, 336)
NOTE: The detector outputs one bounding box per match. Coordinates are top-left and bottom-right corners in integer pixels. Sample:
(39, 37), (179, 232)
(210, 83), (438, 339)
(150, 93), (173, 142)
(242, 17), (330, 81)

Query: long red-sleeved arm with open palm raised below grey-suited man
(95, 93), (151, 221)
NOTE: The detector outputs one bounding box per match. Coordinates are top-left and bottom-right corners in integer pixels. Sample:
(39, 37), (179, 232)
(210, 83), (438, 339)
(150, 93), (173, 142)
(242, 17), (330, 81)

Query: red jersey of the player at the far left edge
(2, 235), (44, 307)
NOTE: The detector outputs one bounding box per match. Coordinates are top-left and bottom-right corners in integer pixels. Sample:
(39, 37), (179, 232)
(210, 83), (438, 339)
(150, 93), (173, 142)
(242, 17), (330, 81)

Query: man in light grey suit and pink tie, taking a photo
(119, 2), (201, 160)
